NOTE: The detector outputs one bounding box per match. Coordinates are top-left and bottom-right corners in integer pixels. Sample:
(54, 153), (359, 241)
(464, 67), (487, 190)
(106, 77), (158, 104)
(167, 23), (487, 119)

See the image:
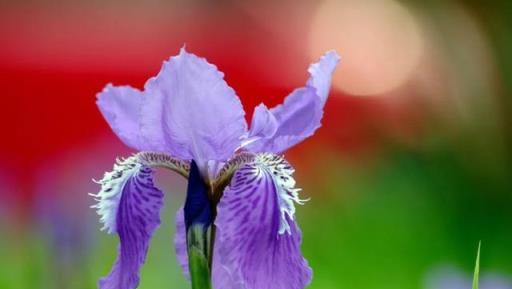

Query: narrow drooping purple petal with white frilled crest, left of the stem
(93, 156), (163, 289)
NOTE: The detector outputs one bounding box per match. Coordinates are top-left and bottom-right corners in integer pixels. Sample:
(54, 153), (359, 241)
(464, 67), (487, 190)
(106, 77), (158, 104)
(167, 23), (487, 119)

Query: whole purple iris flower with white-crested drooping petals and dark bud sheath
(94, 48), (339, 289)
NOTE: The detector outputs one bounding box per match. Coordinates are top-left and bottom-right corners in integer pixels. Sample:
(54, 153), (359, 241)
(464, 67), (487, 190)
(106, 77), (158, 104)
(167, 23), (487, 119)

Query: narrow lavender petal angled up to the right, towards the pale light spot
(246, 51), (340, 153)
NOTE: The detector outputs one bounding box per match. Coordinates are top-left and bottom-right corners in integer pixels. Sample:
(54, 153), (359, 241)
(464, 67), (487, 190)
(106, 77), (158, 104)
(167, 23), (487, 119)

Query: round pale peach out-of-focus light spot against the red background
(310, 0), (424, 95)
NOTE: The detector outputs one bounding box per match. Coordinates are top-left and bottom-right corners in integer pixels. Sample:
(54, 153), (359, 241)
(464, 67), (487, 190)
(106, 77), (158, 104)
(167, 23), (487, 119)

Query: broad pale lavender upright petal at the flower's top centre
(141, 49), (247, 163)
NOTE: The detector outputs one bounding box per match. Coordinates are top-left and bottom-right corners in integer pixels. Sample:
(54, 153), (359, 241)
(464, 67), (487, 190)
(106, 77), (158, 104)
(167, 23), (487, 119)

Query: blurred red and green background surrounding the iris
(0, 0), (512, 289)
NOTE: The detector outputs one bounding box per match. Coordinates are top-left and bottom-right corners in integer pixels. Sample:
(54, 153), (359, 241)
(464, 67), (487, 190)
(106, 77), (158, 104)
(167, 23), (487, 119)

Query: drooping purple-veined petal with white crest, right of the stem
(213, 154), (312, 289)
